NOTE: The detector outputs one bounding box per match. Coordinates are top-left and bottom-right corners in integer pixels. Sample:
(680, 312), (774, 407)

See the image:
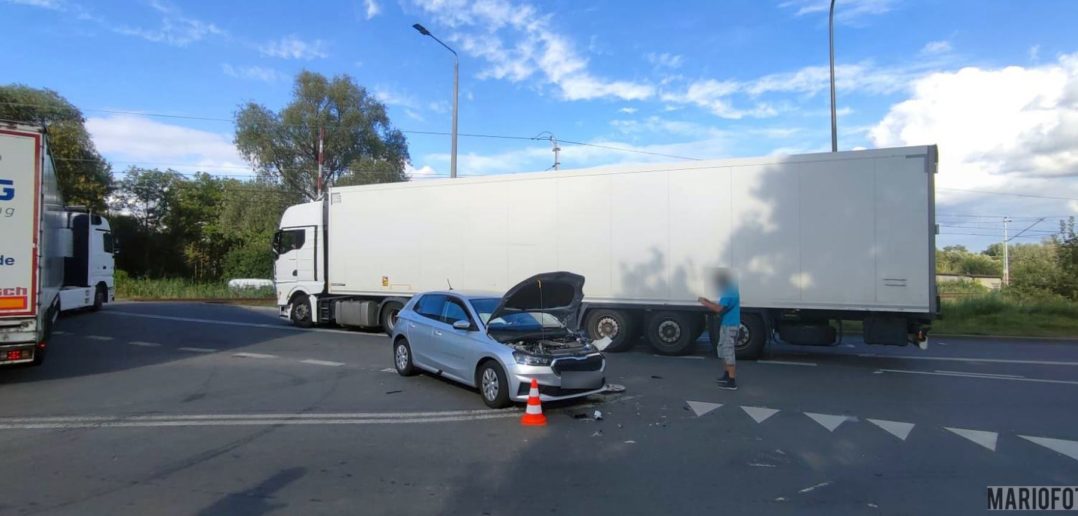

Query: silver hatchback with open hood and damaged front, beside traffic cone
(392, 273), (606, 408)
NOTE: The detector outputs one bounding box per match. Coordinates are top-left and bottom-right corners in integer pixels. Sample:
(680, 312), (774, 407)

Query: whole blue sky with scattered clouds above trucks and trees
(0, 0), (1078, 248)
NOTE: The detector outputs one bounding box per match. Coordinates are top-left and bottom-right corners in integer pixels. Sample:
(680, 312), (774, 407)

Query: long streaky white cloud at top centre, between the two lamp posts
(414, 0), (655, 100)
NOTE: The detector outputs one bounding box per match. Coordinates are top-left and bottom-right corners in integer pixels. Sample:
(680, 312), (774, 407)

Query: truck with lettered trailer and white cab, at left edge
(0, 122), (115, 365)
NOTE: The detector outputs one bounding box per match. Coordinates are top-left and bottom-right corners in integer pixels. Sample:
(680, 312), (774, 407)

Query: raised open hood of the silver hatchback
(487, 271), (584, 332)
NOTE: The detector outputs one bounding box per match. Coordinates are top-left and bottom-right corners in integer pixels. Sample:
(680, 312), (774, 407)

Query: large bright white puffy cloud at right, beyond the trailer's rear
(870, 54), (1078, 212)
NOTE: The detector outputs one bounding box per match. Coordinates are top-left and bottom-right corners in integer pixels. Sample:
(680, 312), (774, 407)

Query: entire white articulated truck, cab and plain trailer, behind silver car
(274, 145), (939, 357)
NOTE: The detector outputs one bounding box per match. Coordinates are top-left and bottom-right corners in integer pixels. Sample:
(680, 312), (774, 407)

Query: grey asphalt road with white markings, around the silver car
(0, 303), (1078, 515)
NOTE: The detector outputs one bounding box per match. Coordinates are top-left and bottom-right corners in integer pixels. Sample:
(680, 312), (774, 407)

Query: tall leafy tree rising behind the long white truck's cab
(235, 71), (409, 199)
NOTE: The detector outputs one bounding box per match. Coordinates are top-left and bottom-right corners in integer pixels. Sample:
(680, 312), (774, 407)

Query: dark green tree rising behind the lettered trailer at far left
(0, 84), (112, 211)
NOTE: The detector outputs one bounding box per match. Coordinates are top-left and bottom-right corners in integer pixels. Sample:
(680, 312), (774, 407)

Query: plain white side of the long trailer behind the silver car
(328, 147), (935, 313)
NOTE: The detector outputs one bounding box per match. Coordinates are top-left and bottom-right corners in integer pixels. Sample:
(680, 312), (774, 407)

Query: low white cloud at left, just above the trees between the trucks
(86, 114), (252, 176)
